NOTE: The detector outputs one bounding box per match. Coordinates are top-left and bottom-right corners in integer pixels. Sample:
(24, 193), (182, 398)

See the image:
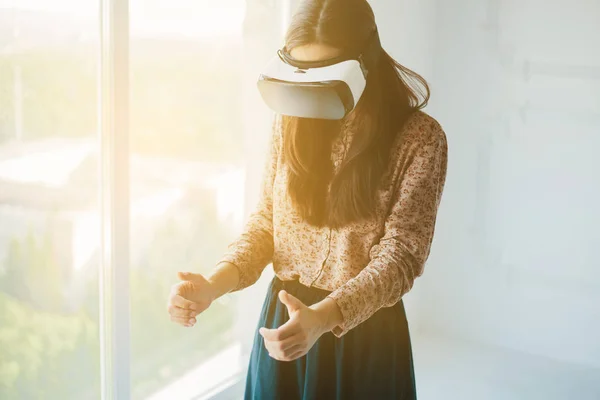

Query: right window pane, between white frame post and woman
(130, 0), (245, 399)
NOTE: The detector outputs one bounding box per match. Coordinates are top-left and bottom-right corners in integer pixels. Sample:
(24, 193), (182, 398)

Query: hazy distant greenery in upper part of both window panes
(0, 41), (241, 161)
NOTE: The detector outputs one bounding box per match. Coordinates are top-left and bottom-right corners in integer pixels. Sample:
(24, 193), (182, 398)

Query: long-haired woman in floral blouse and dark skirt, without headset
(169, 0), (447, 400)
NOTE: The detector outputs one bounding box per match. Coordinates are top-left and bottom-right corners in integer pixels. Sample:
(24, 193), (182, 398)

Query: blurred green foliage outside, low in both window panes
(0, 198), (235, 400)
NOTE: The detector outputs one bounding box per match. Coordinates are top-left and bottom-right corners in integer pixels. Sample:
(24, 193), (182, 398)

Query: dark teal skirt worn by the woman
(244, 277), (417, 400)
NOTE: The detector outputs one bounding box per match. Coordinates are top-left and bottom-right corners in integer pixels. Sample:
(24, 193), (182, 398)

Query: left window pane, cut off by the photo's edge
(0, 0), (100, 399)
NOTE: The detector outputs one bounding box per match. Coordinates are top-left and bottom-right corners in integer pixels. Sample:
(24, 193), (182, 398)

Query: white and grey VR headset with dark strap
(258, 30), (381, 120)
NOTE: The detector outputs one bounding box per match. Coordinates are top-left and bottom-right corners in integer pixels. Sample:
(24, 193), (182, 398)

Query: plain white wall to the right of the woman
(390, 0), (600, 366)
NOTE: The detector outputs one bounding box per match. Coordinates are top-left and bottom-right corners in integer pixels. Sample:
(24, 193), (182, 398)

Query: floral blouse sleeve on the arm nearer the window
(217, 117), (282, 292)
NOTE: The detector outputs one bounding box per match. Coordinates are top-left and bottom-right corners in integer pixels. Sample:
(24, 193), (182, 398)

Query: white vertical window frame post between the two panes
(98, 0), (131, 400)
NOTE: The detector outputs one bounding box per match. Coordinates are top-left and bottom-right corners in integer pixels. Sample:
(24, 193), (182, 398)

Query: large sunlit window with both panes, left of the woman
(0, 0), (289, 400)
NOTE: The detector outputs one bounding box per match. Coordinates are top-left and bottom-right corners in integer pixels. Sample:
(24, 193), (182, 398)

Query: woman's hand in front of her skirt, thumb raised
(258, 290), (337, 361)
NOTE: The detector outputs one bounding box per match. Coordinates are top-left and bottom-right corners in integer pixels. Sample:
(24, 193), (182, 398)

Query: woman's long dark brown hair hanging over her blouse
(283, 0), (429, 228)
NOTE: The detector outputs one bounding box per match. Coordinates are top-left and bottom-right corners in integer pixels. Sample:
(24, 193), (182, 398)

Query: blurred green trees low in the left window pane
(0, 225), (99, 399)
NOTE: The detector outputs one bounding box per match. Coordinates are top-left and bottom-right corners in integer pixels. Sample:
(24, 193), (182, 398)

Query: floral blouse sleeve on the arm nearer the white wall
(328, 122), (448, 337)
